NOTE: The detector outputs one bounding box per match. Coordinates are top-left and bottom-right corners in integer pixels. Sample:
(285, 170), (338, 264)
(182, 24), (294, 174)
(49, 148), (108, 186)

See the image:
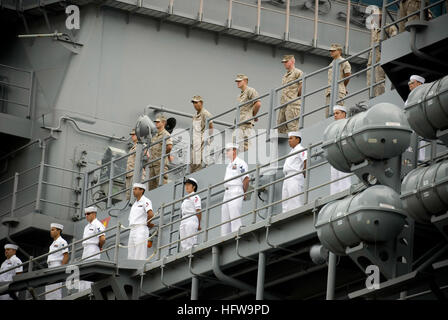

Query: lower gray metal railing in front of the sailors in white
(0, 133), (447, 296)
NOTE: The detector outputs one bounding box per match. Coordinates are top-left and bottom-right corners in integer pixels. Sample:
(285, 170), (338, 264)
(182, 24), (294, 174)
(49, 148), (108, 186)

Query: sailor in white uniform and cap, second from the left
(45, 223), (68, 300)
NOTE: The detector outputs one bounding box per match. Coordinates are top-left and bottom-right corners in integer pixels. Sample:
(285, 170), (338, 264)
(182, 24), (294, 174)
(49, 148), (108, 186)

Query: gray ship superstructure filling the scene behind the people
(0, 0), (448, 300)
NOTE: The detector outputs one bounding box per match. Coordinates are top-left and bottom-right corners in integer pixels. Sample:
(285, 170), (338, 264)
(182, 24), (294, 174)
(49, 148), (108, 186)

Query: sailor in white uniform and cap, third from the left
(79, 207), (106, 291)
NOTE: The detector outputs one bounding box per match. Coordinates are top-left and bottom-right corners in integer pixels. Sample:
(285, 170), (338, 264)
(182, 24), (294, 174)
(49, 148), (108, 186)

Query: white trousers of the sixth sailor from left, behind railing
(221, 186), (244, 236)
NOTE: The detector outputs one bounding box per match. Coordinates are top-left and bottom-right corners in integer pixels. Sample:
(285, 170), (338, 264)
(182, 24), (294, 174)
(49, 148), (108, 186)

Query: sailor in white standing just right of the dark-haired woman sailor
(221, 143), (249, 236)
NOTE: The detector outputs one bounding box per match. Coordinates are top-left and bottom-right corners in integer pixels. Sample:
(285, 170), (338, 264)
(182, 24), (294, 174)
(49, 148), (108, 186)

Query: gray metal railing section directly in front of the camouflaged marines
(83, 39), (385, 207)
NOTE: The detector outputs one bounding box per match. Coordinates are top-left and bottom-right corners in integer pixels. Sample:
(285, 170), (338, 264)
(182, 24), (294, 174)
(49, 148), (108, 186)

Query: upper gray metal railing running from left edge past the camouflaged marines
(0, 35), (416, 220)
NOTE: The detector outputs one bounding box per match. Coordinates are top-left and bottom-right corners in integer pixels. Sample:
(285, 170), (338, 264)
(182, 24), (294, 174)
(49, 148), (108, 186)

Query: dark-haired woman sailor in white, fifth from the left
(179, 178), (201, 250)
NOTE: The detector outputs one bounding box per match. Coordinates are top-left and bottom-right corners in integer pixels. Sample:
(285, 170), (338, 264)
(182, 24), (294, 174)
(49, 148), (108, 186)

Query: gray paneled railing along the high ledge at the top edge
(135, 0), (369, 54)
